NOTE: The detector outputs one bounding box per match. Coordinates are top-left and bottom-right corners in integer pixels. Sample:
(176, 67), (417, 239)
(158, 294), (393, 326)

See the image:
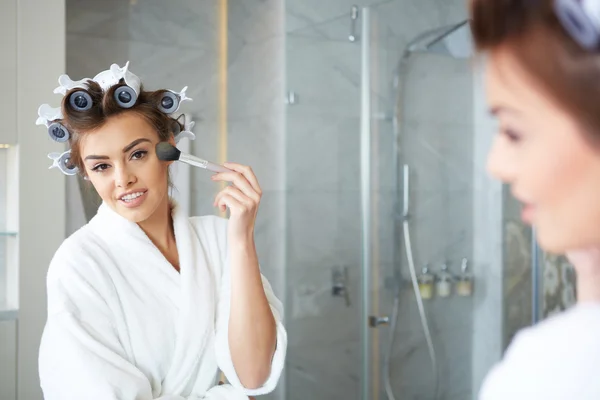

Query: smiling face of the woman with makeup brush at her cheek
(80, 112), (169, 223)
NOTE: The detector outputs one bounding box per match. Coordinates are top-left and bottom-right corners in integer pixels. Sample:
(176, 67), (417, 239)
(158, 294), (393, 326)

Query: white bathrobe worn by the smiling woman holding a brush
(39, 205), (287, 400)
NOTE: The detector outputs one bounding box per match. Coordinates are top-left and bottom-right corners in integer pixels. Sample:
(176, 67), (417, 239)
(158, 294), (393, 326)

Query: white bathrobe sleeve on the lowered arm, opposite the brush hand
(39, 239), (246, 400)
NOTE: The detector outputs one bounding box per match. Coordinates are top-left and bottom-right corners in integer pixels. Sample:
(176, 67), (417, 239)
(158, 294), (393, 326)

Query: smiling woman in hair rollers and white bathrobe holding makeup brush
(38, 65), (287, 400)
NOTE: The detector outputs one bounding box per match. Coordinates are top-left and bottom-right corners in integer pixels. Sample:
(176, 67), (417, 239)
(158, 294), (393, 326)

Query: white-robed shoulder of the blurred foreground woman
(480, 304), (600, 400)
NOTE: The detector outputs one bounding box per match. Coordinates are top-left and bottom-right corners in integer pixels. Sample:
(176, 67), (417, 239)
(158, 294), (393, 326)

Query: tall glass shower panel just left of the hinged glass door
(285, 6), (362, 400)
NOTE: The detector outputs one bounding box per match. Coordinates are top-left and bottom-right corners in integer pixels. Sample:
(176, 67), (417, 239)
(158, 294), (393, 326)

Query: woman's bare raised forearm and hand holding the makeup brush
(213, 163), (277, 389)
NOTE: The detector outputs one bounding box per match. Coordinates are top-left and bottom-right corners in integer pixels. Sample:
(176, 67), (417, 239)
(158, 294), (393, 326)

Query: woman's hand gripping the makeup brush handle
(211, 163), (262, 243)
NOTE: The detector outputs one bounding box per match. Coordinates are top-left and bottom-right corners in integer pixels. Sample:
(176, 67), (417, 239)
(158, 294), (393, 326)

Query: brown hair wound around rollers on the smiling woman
(59, 80), (183, 175)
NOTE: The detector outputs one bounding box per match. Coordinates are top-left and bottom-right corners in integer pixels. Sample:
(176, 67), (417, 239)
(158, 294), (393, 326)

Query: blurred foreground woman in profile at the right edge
(471, 0), (600, 400)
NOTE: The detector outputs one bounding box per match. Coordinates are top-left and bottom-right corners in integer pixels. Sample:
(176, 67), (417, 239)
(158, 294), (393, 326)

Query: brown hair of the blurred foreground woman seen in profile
(470, 0), (600, 139)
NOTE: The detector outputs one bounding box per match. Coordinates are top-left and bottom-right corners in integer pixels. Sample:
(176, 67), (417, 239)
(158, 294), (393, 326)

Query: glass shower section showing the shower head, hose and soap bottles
(361, 1), (503, 400)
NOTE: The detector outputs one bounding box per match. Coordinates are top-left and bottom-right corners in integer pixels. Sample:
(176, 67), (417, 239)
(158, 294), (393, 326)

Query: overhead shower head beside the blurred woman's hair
(407, 20), (473, 58)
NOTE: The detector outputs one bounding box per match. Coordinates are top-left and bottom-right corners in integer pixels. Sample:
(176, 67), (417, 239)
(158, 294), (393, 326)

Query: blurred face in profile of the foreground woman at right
(486, 49), (600, 253)
